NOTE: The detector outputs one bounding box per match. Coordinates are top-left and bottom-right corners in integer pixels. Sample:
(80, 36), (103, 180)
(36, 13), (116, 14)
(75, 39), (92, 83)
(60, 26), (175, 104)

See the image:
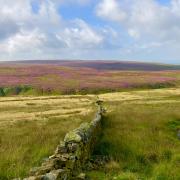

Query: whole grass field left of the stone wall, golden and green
(0, 96), (95, 180)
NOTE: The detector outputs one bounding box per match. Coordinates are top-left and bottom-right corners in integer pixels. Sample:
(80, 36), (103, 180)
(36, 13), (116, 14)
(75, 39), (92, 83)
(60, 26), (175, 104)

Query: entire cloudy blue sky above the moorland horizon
(0, 0), (180, 64)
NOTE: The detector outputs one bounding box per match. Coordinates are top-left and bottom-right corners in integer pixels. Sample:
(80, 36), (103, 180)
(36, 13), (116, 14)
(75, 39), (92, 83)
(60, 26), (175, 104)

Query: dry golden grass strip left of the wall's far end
(0, 96), (95, 127)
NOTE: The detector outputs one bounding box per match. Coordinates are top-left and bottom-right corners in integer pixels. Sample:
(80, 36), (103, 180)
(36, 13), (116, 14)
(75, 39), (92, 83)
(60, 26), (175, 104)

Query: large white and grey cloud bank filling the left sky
(0, 0), (109, 59)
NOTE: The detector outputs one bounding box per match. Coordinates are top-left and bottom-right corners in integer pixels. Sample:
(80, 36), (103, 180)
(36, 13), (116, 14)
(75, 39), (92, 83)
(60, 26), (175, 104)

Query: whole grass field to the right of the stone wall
(89, 88), (180, 180)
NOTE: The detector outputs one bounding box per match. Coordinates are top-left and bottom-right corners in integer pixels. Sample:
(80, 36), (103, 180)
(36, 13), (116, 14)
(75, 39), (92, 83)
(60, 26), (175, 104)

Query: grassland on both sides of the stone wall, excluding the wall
(0, 87), (180, 180)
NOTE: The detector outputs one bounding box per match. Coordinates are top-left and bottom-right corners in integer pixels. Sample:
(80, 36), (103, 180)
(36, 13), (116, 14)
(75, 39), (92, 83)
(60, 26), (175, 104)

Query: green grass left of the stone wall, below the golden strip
(0, 116), (94, 180)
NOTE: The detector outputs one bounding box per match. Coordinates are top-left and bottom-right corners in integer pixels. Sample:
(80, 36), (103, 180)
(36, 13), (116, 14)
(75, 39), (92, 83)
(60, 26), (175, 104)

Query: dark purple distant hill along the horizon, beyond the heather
(3, 60), (180, 71)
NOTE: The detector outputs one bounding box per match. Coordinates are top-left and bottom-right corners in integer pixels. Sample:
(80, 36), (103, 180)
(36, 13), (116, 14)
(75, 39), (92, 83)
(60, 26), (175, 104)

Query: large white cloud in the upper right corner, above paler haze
(96, 0), (180, 40)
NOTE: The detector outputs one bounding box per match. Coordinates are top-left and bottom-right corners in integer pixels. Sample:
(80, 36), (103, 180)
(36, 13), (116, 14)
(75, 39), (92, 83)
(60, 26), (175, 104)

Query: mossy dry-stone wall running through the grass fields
(24, 101), (103, 180)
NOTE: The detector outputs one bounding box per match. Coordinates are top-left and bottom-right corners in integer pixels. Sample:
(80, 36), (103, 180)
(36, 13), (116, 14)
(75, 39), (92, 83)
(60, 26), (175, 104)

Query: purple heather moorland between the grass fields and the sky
(0, 61), (180, 96)
